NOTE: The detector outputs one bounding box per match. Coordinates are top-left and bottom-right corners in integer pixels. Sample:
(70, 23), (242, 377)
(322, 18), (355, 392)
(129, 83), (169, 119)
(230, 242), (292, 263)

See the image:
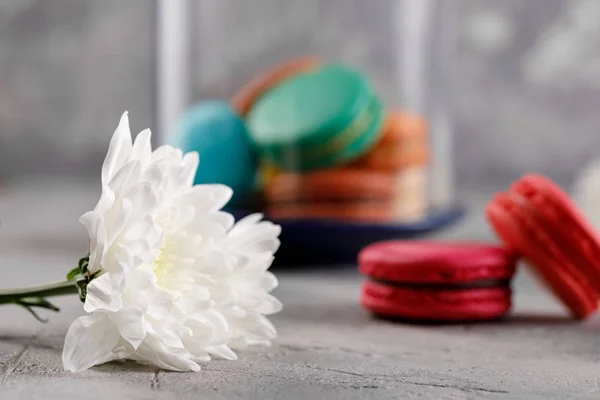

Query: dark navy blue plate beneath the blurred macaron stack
(228, 206), (464, 267)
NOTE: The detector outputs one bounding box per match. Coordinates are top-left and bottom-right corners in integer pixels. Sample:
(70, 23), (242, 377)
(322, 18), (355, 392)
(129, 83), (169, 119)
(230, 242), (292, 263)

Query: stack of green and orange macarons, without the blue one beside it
(237, 58), (429, 223)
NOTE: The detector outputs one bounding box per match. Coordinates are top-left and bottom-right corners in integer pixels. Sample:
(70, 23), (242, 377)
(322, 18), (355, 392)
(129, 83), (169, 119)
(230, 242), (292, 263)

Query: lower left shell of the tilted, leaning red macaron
(486, 194), (598, 318)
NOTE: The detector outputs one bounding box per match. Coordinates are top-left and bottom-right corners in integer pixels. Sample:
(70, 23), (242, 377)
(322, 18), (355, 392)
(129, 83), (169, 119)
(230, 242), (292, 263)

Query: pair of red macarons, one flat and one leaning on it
(359, 174), (600, 322)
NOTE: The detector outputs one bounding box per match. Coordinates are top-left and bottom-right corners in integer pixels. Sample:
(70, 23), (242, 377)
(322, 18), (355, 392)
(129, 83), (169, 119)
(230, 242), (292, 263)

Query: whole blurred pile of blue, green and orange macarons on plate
(170, 57), (429, 223)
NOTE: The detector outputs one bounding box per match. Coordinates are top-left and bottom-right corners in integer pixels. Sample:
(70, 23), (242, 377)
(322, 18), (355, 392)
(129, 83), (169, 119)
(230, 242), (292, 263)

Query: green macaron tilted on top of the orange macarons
(246, 64), (384, 172)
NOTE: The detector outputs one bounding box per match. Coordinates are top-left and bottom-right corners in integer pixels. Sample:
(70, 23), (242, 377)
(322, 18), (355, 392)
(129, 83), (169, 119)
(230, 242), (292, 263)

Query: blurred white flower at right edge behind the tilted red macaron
(573, 160), (600, 229)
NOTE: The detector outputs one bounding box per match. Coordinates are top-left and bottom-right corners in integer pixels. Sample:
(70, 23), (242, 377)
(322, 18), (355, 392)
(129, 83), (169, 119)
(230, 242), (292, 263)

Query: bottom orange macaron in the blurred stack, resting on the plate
(265, 167), (425, 222)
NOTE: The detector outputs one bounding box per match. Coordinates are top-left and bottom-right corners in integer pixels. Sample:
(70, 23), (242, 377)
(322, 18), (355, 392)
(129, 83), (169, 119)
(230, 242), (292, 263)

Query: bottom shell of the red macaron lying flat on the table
(361, 282), (511, 322)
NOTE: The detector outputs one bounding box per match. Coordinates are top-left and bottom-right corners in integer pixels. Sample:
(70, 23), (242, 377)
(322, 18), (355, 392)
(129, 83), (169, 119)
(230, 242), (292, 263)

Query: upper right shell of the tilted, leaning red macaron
(511, 175), (600, 291)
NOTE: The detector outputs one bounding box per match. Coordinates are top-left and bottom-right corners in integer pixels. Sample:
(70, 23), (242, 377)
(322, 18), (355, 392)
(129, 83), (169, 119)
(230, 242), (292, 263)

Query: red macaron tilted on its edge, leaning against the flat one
(486, 174), (600, 319)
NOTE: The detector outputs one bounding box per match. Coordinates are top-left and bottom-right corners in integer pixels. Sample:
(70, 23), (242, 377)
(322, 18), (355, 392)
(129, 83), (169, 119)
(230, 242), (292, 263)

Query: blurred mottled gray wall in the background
(0, 0), (600, 188)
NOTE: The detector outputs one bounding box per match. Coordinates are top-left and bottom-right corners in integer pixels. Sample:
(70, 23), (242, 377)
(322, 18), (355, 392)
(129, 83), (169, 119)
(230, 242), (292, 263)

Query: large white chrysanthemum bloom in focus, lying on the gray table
(63, 113), (281, 371)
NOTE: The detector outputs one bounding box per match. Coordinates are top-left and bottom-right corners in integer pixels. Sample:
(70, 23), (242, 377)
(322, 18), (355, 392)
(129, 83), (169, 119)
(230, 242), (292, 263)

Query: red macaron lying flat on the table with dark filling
(359, 241), (517, 322)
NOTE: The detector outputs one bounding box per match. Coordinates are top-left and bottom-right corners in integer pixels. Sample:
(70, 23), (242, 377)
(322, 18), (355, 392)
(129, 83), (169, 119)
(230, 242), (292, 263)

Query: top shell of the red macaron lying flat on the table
(358, 240), (517, 284)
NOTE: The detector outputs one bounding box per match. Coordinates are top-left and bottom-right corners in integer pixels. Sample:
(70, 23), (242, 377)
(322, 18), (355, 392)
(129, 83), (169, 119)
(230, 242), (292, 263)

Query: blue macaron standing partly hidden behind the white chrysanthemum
(168, 101), (258, 205)
